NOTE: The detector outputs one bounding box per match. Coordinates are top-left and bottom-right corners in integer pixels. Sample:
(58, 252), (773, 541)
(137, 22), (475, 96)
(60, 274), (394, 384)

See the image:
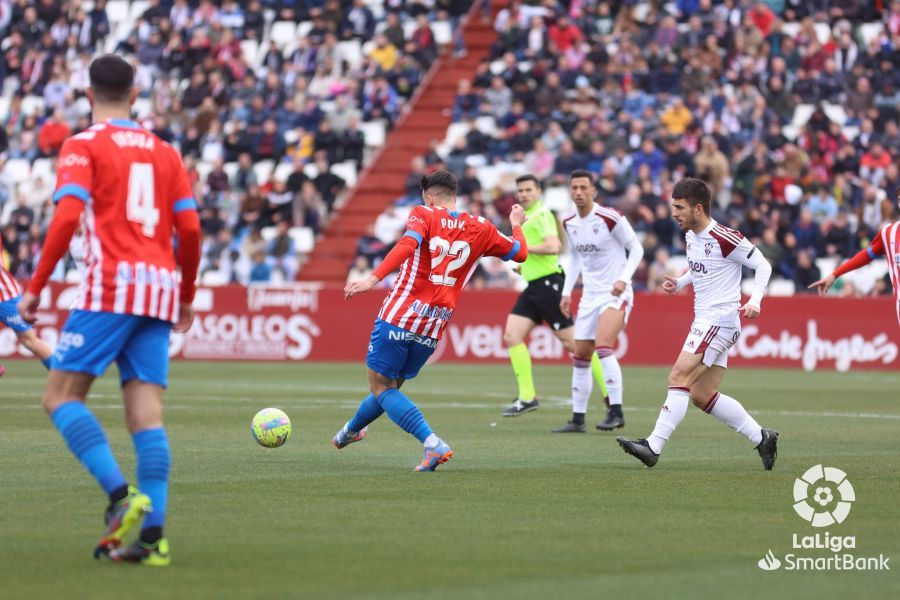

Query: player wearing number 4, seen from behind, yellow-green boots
(20, 55), (200, 566)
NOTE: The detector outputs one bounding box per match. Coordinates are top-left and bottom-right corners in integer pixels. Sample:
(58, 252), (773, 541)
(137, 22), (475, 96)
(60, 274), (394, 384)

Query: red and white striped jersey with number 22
(376, 206), (524, 339)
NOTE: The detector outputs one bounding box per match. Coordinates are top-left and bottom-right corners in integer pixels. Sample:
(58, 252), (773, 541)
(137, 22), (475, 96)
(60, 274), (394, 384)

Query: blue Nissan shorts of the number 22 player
(366, 319), (438, 379)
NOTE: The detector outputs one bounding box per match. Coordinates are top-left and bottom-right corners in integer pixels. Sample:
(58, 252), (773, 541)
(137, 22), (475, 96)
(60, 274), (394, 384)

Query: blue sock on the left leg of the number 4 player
(50, 400), (128, 494)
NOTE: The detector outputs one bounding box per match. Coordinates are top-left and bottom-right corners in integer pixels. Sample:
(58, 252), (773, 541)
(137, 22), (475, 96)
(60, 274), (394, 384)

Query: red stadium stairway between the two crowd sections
(298, 2), (506, 284)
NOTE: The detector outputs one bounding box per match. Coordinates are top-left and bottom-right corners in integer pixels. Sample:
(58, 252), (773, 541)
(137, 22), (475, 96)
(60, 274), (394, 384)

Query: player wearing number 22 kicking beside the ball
(332, 171), (528, 471)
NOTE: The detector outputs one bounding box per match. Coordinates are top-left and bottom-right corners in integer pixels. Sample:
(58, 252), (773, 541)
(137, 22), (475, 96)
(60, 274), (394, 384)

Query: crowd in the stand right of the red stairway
(357, 0), (900, 294)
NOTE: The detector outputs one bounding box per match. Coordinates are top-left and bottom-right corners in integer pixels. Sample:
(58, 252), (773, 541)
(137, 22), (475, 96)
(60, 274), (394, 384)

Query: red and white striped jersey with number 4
(53, 119), (196, 321)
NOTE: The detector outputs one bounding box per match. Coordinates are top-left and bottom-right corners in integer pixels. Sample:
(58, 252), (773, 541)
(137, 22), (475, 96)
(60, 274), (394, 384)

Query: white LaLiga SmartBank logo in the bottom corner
(756, 465), (891, 571)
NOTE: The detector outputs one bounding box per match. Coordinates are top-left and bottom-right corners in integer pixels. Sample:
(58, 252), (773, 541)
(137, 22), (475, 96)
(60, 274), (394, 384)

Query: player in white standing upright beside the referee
(553, 170), (644, 433)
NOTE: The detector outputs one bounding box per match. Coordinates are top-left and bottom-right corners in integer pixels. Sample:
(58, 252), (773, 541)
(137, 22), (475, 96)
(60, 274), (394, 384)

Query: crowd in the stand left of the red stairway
(0, 0), (466, 284)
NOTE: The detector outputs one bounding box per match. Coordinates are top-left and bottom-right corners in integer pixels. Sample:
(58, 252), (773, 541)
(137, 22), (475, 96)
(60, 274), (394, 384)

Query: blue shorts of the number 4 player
(50, 310), (172, 387)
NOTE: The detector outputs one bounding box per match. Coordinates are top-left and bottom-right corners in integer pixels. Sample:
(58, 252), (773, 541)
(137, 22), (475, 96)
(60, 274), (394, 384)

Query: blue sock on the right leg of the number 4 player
(131, 427), (172, 529)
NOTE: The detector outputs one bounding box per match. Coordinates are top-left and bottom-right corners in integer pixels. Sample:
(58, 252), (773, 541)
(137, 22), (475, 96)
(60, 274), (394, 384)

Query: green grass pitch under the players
(0, 362), (900, 600)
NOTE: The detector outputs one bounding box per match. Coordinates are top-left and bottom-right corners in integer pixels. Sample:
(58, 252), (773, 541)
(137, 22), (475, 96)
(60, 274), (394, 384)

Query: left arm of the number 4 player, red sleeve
(19, 138), (93, 323)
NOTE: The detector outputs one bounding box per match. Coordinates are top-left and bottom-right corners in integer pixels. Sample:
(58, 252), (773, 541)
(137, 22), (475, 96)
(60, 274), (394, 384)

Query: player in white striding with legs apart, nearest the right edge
(617, 177), (778, 470)
